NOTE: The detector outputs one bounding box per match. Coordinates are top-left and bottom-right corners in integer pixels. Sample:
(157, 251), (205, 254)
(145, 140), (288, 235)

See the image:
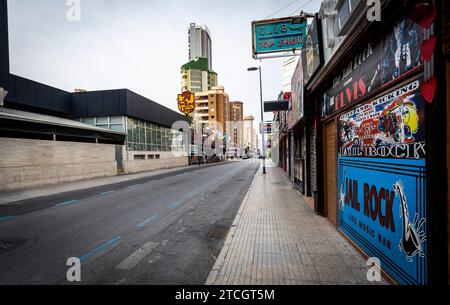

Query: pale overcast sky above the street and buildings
(8, 0), (321, 127)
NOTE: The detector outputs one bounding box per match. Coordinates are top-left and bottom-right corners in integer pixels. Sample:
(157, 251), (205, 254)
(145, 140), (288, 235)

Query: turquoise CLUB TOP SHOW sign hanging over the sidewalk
(252, 17), (307, 58)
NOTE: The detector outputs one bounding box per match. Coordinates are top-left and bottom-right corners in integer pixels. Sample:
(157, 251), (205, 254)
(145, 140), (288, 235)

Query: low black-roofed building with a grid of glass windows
(72, 89), (186, 160)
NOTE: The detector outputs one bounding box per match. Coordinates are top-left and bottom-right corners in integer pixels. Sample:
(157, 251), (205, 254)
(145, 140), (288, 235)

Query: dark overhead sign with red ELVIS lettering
(322, 17), (421, 119)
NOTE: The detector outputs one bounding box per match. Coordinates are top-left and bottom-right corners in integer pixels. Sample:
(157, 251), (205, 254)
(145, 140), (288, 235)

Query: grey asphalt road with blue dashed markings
(0, 161), (259, 285)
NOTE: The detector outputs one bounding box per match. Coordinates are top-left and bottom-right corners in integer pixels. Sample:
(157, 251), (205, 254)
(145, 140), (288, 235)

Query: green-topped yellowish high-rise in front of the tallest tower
(181, 57), (217, 93)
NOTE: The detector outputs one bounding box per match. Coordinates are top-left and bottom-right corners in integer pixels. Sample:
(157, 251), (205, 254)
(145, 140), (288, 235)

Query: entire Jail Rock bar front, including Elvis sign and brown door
(317, 1), (446, 285)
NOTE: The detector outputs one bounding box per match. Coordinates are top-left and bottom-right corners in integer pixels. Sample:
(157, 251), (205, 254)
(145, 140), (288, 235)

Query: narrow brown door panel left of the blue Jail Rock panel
(323, 121), (337, 225)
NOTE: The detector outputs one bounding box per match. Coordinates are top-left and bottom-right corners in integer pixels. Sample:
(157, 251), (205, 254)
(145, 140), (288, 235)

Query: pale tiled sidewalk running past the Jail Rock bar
(206, 162), (386, 285)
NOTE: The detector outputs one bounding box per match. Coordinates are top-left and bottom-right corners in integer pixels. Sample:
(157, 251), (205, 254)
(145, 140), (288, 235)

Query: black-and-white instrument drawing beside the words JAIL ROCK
(394, 181), (427, 262)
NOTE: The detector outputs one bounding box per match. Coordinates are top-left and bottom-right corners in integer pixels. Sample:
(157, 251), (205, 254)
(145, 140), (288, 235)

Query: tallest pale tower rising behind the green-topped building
(188, 23), (212, 70)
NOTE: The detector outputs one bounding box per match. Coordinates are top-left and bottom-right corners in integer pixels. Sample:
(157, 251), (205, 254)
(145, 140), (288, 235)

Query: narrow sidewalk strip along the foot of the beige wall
(0, 162), (228, 206)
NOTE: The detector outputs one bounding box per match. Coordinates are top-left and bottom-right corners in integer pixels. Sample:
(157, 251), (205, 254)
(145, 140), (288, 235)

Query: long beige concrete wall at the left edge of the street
(0, 138), (117, 191)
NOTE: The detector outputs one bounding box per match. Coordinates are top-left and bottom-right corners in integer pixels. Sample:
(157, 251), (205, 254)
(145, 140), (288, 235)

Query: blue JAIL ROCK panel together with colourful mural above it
(338, 79), (427, 285)
